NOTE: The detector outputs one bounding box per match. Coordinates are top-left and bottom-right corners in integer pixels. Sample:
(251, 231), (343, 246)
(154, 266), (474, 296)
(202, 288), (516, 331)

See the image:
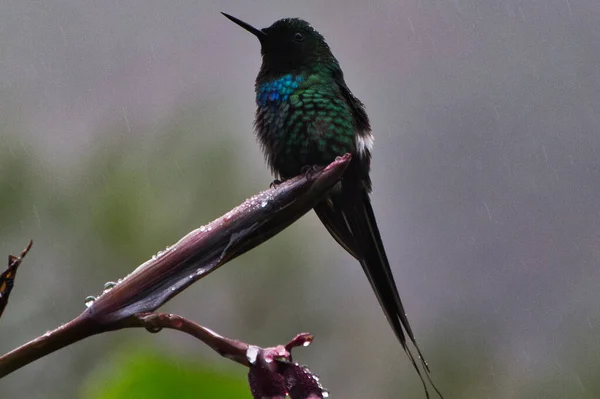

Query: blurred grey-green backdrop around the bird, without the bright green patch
(0, 0), (600, 398)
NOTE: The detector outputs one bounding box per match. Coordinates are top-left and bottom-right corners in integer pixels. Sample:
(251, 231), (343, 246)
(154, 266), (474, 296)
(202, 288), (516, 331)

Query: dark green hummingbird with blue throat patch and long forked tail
(222, 13), (442, 397)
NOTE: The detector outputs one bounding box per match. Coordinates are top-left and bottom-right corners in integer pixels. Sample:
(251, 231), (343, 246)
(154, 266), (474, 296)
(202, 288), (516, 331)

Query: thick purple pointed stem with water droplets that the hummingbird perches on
(0, 154), (350, 378)
